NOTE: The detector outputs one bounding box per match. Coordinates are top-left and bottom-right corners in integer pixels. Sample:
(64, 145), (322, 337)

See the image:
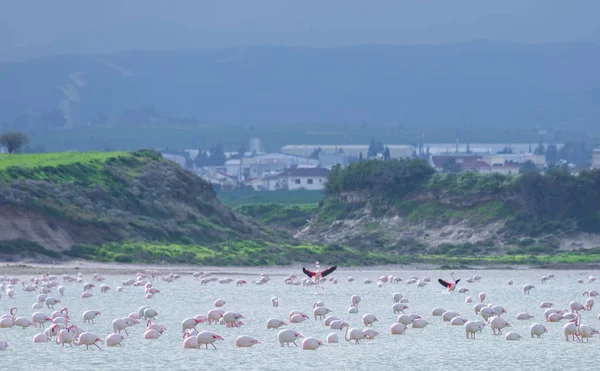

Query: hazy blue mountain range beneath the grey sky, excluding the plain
(0, 42), (600, 140)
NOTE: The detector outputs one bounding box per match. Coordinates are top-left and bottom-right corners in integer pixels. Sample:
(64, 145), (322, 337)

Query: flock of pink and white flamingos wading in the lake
(0, 267), (600, 351)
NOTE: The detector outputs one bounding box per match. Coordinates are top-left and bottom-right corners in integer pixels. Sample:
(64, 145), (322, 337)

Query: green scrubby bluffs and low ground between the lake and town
(0, 151), (600, 267)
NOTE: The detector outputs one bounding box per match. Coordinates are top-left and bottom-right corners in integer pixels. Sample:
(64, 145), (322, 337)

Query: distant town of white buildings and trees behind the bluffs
(162, 138), (600, 191)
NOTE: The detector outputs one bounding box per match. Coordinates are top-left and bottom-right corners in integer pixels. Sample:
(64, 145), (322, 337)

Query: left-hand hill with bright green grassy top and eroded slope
(0, 151), (264, 258)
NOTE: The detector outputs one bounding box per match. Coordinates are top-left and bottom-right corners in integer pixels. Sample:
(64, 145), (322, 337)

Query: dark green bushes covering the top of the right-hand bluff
(326, 160), (600, 236)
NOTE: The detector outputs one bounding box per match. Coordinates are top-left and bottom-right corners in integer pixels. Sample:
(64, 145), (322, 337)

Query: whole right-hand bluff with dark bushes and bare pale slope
(303, 160), (600, 261)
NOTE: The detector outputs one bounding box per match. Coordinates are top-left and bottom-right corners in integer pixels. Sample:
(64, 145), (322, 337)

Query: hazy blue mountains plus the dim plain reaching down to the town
(0, 42), (600, 156)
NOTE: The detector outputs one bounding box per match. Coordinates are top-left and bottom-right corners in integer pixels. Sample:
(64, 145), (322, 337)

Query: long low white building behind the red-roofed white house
(281, 144), (414, 158)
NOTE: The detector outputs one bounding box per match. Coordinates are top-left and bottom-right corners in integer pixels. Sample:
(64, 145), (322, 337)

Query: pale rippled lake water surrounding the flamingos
(0, 269), (600, 370)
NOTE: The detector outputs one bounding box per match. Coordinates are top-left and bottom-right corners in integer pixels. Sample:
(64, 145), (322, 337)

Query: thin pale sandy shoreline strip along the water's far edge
(0, 260), (600, 276)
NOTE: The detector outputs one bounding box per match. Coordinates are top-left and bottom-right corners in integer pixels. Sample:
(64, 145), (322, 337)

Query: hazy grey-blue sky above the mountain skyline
(0, 0), (600, 60)
